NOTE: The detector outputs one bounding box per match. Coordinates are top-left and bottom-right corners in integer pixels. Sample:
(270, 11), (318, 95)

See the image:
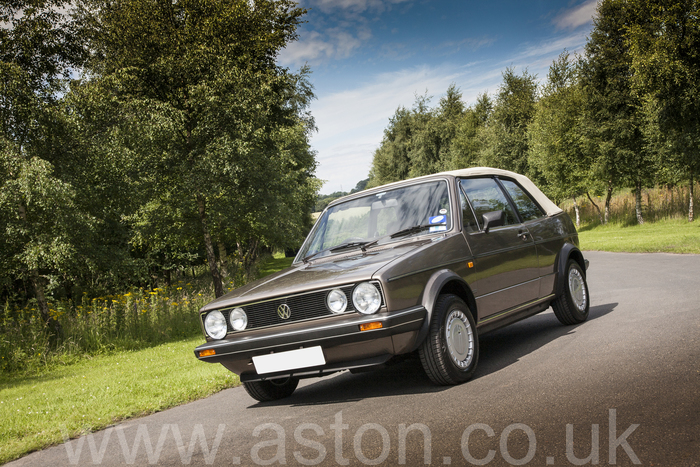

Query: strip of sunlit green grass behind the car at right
(579, 219), (700, 254)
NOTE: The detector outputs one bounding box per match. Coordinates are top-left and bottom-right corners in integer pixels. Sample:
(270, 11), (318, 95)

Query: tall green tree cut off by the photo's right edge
(627, 0), (700, 222)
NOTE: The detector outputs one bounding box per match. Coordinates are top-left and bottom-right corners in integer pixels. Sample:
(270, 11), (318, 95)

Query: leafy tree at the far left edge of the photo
(0, 0), (89, 341)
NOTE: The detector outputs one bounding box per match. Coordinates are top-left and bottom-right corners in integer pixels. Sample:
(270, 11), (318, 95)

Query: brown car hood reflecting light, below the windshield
(200, 239), (431, 311)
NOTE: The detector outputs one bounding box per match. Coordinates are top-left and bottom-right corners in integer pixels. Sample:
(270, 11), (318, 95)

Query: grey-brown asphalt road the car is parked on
(10, 252), (700, 467)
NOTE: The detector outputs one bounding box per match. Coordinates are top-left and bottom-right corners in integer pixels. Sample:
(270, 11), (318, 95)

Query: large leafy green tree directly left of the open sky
(79, 0), (315, 296)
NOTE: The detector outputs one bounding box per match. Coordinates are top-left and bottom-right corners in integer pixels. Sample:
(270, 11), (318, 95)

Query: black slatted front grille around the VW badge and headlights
(202, 282), (384, 332)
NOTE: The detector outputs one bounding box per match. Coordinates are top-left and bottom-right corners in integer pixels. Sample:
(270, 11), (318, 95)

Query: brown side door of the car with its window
(459, 178), (540, 321)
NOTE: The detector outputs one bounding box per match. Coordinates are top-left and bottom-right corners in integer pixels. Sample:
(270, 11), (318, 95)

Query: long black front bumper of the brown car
(194, 306), (427, 363)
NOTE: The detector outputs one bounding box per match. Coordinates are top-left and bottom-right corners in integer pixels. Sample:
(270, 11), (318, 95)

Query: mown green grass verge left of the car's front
(0, 337), (239, 464)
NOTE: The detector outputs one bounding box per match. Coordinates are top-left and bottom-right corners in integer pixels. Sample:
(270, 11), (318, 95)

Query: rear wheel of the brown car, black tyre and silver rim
(552, 259), (591, 325)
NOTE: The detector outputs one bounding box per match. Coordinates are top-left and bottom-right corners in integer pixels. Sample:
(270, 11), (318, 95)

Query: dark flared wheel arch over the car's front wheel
(412, 269), (479, 350)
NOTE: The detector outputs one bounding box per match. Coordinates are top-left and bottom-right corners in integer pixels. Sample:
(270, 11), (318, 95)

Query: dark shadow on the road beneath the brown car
(249, 303), (618, 408)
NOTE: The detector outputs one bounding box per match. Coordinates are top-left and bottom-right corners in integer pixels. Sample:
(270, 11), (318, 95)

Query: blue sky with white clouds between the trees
(279, 0), (597, 194)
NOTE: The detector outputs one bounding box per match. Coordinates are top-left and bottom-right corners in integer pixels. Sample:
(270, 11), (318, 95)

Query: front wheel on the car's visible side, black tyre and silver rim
(418, 295), (479, 386)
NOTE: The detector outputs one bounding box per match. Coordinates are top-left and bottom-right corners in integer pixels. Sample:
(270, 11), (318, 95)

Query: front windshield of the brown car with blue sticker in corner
(297, 180), (452, 259)
